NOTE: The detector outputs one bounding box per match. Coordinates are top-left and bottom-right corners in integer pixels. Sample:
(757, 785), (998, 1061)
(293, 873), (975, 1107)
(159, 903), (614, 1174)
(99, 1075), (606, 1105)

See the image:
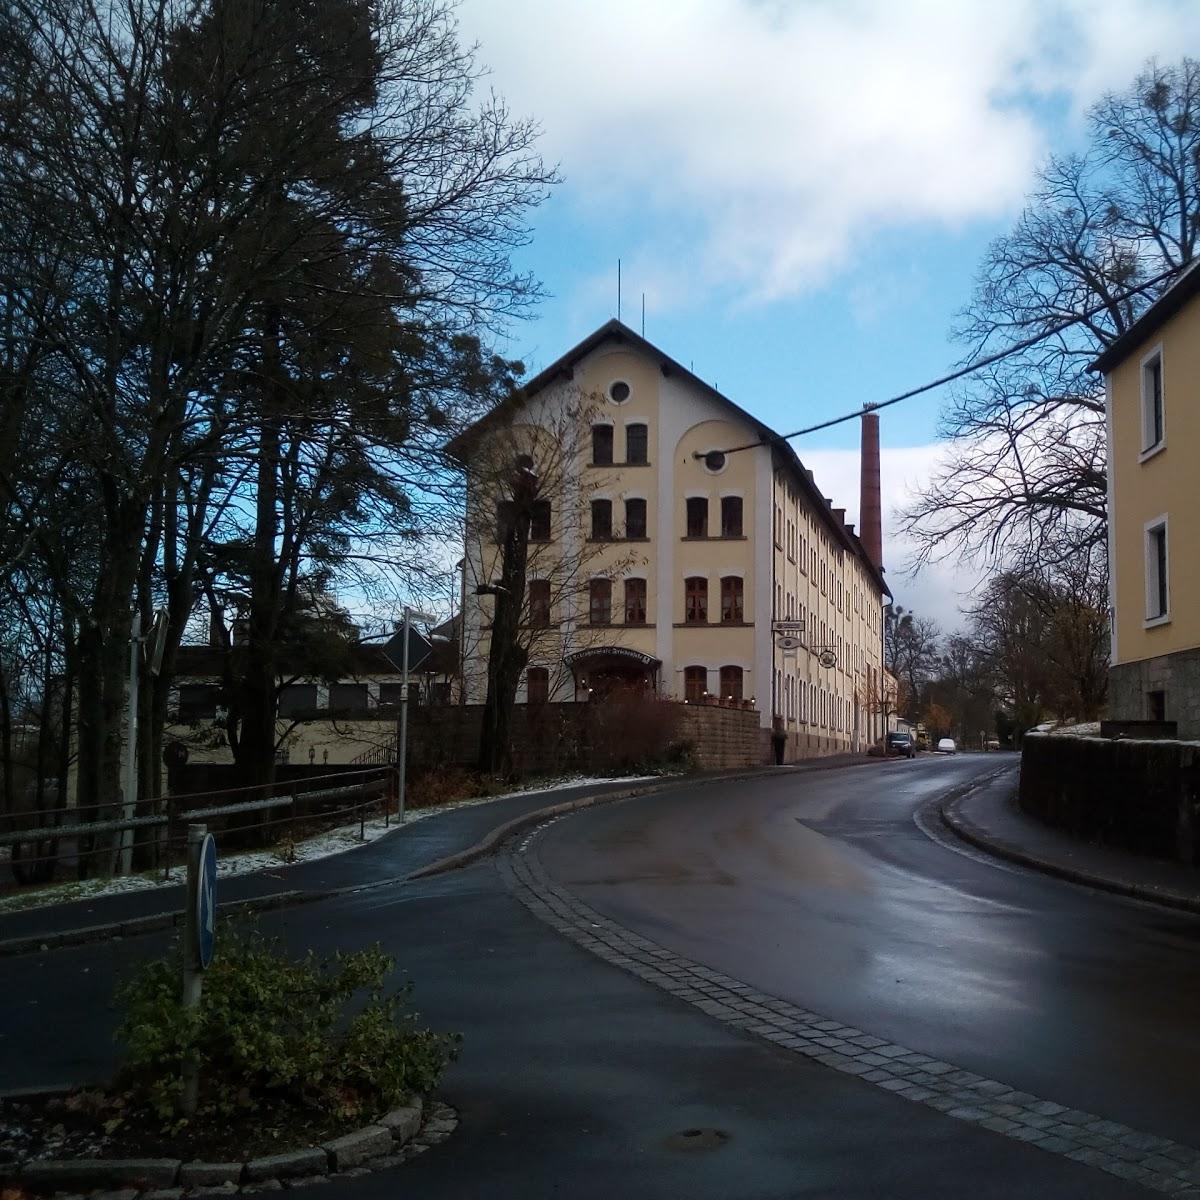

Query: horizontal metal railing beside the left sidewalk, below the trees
(0, 766), (397, 883)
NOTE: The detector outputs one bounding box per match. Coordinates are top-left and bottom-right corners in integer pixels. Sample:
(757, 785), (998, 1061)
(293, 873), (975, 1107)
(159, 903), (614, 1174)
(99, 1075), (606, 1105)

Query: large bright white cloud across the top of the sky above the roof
(460, 0), (1200, 307)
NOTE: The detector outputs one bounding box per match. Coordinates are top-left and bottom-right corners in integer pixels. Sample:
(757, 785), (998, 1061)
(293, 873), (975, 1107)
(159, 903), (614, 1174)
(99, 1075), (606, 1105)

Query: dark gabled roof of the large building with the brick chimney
(446, 318), (892, 598)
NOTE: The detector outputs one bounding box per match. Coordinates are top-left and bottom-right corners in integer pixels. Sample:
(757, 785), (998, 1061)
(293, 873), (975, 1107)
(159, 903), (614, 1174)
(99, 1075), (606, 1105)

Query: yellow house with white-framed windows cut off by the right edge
(1093, 268), (1200, 738)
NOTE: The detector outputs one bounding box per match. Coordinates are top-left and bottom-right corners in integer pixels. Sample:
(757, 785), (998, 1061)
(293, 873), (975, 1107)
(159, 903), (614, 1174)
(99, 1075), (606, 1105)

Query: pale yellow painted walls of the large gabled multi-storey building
(466, 321), (882, 752)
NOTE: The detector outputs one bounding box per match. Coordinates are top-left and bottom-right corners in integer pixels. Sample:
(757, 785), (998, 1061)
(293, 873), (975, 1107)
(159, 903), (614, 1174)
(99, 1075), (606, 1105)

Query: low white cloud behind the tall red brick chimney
(797, 442), (980, 632)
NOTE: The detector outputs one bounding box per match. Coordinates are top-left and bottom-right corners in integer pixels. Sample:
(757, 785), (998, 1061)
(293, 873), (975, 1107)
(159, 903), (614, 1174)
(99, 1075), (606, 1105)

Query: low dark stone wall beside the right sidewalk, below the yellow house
(1020, 733), (1200, 864)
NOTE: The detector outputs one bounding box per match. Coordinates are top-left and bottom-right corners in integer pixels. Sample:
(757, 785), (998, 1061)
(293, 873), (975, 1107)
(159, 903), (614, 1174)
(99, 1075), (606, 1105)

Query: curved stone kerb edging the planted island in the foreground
(4, 1098), (458, 1200)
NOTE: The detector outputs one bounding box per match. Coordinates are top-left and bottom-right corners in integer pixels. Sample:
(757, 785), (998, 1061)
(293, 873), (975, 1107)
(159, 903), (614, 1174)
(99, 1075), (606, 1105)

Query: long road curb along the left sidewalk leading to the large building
(0, 756), (887, 959)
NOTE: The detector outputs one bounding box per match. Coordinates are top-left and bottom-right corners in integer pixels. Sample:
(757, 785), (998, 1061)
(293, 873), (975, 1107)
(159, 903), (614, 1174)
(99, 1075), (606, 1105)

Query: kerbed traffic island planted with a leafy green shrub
(0, 916), (461, 1200)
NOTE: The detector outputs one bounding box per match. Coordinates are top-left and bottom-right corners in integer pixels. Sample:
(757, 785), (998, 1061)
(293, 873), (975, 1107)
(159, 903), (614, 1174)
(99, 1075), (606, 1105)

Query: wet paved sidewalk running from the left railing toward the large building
(0, 755), (883, 954)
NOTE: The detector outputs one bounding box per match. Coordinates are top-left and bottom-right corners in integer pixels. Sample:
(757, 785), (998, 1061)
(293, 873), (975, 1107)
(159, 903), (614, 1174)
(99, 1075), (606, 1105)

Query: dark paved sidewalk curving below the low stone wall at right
(941, 766), (1200, 912)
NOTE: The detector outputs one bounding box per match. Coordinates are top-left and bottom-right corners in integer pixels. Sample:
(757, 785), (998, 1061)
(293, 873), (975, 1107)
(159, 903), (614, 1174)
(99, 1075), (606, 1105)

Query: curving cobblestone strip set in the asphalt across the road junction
(499, 818), (1200, 1200)
